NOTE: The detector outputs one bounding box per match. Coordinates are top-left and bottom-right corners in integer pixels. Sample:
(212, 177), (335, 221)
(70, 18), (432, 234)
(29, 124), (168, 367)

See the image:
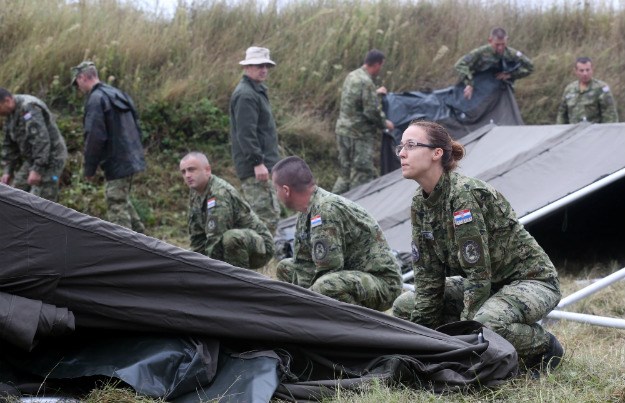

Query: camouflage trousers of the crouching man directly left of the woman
(276, 258), (399, 311)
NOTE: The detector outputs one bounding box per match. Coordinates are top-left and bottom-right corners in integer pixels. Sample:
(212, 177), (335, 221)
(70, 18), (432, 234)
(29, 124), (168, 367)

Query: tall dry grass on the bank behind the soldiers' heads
(0, 0), (625, 124)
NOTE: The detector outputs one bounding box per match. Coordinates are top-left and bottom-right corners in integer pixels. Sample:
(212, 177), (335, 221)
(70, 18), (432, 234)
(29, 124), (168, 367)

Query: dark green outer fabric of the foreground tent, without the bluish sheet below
(0, 185), (517, 400)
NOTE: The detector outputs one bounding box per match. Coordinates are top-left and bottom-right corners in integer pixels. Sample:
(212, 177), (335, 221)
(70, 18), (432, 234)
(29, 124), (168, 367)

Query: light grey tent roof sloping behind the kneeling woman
(279, 123), (625, 251)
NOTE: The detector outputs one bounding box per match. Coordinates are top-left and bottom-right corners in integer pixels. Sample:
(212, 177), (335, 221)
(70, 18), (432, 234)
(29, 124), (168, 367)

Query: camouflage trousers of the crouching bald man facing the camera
(221, 229), (272, 269)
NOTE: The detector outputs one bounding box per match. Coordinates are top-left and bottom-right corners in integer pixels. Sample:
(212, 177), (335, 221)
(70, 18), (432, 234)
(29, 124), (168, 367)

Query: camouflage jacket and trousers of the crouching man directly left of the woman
(277, 187), (401, 311)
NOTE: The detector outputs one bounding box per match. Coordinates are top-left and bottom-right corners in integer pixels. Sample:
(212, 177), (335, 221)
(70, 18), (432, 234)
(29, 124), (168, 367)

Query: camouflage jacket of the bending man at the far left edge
(2, 95), (67, 175)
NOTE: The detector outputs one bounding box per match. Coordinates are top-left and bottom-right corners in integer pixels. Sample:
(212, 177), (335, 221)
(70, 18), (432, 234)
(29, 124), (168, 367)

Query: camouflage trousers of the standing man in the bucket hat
(241, 177), (280, 235)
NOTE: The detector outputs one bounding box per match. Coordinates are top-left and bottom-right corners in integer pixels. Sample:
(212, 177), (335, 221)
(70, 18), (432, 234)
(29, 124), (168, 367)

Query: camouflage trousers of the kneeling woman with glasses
(393, 277), (561, 360)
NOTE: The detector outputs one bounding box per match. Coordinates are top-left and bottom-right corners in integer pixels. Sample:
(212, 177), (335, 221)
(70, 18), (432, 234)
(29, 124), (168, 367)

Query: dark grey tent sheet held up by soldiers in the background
(380, 70), (523, 175)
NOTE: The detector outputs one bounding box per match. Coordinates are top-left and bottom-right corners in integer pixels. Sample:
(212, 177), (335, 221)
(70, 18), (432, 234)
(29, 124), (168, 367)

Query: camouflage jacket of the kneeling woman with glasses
(411, 172), (559, 328)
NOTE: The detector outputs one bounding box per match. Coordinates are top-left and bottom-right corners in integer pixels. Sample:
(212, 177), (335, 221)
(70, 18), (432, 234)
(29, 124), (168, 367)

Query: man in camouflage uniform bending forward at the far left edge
(0, 88), (67, 201)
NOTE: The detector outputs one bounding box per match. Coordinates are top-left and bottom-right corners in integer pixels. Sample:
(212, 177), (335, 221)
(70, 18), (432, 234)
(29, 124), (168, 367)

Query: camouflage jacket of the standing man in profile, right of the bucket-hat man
(336, 67), (386, 139)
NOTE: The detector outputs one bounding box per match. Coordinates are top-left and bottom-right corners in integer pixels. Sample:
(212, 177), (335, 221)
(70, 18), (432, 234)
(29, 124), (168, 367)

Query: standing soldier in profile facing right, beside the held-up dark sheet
(332, 49), (394, 194)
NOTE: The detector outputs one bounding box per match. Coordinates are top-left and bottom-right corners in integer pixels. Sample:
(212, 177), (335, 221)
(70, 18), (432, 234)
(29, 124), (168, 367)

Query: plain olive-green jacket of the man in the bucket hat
(230, 75), (280, 179)
